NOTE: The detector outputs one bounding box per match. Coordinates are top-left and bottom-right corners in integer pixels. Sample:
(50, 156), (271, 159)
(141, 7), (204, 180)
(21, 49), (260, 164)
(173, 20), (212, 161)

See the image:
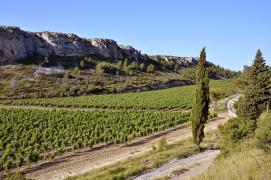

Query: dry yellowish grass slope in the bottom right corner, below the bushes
(193, 140), (271, 180)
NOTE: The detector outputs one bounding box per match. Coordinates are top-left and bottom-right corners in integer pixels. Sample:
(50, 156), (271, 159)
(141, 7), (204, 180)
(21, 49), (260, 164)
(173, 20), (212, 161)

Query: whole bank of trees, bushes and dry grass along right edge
(195, 50), (271, 180)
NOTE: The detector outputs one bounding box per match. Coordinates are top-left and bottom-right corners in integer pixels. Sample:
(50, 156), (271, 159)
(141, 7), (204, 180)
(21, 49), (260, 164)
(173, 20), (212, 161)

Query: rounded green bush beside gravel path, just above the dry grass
(219, 118), (255, 151)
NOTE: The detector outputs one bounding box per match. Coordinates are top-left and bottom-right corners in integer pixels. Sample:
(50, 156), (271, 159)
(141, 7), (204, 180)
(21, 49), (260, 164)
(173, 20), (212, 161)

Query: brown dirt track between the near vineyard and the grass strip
(8, 94), (240, 180)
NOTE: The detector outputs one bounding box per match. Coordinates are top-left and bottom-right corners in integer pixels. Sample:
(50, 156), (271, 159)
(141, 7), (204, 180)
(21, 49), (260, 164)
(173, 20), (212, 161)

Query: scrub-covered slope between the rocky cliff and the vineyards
(0, 57), (238, 99)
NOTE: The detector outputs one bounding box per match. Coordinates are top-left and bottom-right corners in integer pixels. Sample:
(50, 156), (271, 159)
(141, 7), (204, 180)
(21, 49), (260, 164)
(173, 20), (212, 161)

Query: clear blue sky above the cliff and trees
(0, 0), (271, 70)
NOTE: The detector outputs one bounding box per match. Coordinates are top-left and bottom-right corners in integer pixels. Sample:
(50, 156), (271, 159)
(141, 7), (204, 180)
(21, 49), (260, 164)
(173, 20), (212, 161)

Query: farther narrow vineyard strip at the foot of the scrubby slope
(0, 79), (234, 110)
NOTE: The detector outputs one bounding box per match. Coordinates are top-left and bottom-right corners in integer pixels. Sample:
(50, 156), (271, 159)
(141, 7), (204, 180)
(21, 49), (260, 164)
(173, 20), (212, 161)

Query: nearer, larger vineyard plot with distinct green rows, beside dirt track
(0, 108), (190, 170)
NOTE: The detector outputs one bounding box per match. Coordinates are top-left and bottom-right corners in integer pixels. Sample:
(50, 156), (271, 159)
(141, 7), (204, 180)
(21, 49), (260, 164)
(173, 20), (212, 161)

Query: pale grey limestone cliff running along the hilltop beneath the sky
(0, 26), (200, 66)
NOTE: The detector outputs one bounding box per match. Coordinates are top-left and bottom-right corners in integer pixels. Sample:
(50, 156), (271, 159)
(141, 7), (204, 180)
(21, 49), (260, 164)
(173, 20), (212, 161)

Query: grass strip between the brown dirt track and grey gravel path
(67, 131), (219, 180)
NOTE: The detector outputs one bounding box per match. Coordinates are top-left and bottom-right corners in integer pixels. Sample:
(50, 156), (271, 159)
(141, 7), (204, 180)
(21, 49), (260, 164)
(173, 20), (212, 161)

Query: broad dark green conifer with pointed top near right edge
(242, 50), (271, 120)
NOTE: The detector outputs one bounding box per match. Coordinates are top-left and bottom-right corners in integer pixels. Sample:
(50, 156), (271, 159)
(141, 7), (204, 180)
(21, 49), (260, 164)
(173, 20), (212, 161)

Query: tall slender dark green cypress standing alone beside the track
(191, 48), (210, 145)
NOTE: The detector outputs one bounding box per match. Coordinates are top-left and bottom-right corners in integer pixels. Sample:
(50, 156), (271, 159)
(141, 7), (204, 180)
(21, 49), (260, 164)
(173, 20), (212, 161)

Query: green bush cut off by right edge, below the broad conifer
(256, 113), (271, 152)
